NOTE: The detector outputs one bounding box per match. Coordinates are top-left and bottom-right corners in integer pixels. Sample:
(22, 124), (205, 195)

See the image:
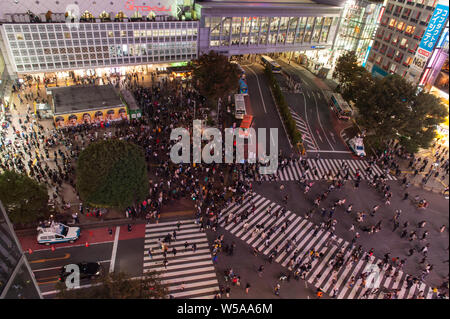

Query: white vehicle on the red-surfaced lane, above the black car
(37, 222), (81, 245)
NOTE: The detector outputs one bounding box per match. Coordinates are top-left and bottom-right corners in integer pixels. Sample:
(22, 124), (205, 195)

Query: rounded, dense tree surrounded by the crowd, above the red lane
(76, 140), (149, 208)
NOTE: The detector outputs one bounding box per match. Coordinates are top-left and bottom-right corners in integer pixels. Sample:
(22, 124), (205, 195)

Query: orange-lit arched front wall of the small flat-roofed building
(53, 107), (128, 128)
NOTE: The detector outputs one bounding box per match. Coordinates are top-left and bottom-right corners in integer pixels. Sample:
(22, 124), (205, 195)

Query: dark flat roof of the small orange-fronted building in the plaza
(48, 84), (124, 115)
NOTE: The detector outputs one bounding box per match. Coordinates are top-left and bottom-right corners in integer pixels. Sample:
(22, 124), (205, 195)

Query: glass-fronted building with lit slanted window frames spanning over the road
(197, 0), (342, 56)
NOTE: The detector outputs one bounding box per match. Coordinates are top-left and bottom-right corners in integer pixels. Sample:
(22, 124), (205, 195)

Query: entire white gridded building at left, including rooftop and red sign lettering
(0, 0), (198, 80)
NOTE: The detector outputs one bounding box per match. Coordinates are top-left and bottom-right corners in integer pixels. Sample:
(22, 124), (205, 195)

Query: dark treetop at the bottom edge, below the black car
(56, 272), (168, 299)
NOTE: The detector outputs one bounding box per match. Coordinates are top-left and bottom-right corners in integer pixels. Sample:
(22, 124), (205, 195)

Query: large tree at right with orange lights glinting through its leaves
(355, 75), (448, 152)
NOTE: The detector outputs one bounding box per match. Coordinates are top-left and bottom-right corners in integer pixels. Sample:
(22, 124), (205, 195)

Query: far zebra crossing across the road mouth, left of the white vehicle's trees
(260, 158), (397, 181)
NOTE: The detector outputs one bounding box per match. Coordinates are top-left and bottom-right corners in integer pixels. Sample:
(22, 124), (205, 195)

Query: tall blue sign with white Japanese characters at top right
(419, 4), (448, 57)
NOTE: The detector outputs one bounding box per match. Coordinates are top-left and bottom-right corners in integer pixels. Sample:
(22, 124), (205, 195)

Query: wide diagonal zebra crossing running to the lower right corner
(219, 193), (433, 299)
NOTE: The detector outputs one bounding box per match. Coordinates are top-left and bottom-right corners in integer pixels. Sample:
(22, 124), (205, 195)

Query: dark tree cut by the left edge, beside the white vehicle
(0, 171), (51, 225)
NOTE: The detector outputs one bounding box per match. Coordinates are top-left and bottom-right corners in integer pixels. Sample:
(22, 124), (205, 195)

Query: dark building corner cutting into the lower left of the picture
(0, 202), (42, 299)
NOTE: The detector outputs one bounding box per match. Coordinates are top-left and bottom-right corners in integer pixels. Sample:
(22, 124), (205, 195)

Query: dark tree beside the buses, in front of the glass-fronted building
(193, 51), (240, 106)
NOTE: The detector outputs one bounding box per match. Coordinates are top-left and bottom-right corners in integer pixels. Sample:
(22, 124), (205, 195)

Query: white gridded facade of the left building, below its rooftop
(2, 21), (198, 73)
